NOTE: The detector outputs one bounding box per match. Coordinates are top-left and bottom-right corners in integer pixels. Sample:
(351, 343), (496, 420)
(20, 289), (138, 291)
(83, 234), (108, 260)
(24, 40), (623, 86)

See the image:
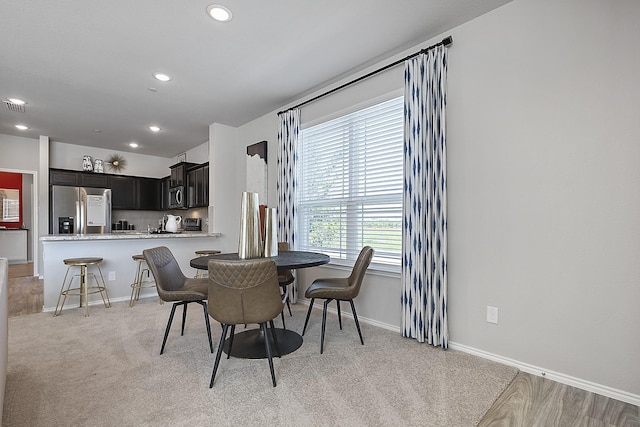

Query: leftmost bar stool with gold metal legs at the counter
(53, 257), (111, 317)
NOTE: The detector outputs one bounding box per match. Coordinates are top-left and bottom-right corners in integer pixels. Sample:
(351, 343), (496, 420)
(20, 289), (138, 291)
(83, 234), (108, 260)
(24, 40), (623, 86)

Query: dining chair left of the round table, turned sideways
(142, 246), (213, 354)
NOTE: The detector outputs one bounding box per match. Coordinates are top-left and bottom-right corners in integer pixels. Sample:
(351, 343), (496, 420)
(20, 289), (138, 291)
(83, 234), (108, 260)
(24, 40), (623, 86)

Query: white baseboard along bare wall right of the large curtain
(449, 341), (640, 406)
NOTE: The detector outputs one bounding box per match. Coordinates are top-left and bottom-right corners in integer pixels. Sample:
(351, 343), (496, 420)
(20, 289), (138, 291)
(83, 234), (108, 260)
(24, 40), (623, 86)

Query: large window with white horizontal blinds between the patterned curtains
(296, 97), (404, 266)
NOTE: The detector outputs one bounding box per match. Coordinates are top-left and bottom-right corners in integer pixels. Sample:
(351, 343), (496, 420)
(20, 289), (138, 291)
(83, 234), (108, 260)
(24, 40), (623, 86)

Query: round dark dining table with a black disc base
(189, 251), (331, 359)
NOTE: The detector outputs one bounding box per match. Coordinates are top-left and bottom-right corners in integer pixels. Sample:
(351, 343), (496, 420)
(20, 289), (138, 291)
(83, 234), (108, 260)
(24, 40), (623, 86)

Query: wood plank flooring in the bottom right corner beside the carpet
(478, 372), (640, 427)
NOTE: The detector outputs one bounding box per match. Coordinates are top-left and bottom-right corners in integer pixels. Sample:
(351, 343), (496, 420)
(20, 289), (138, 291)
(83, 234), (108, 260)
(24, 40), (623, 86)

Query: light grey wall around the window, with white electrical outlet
(226, 0), (640, 404)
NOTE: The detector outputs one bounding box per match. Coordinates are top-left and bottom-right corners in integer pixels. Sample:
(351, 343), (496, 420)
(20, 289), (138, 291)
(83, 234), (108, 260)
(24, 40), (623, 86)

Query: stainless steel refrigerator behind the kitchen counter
(49, 185), (111, 234)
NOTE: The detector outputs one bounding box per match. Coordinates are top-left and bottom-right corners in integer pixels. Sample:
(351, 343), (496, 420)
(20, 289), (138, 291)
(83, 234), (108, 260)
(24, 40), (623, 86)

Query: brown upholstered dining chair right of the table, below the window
(302, 246), (374, 354)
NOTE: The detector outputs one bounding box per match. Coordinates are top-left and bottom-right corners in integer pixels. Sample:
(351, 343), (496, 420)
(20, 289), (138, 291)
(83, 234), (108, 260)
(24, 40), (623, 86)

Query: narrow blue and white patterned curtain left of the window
(276, 109), (300, 303)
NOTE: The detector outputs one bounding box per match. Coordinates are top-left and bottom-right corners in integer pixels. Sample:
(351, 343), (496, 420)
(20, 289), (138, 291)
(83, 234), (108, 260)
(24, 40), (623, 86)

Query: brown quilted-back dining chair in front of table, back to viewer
(208, 258), (284, 388)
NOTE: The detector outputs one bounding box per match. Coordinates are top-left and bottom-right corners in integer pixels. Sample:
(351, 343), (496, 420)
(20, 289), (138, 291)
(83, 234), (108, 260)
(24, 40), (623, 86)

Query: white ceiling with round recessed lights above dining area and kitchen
(0, 0), (510, 157)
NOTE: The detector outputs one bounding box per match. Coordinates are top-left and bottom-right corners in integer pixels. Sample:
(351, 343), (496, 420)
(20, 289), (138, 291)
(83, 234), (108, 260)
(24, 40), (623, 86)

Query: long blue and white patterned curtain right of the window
(402, 46), (449, 349)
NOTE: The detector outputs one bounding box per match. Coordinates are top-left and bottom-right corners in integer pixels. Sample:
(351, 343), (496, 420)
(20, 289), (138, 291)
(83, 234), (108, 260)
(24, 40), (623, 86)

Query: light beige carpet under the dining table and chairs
(2, 299), (517, 427)
